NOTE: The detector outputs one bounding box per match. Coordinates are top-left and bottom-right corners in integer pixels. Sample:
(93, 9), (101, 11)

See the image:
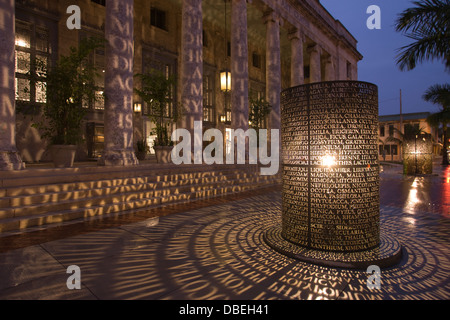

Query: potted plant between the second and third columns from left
(135, 69), (180, 163)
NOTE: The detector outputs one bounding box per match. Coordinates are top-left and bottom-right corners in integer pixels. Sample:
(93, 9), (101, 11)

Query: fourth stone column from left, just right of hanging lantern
(231, 0), (249, 130)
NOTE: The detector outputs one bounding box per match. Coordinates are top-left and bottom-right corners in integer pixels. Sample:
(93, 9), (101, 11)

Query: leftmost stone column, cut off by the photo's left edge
(0, 0), (25, 171)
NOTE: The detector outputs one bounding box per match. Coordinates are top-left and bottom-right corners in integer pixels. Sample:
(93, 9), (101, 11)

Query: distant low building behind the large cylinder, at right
(378, 112), (442, 161)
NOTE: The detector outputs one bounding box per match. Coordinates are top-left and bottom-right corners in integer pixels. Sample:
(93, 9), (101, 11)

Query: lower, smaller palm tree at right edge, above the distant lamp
(423, 83), (450, 165)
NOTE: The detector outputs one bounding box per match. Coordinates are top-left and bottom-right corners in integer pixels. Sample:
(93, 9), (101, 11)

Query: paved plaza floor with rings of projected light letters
(0, 162), (450, 300)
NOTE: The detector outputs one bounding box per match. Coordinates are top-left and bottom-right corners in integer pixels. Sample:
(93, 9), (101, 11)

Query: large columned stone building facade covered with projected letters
(0, 0), (362, 169)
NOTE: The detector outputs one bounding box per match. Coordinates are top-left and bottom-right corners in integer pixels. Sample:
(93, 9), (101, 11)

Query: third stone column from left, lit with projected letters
(180, 0), (203, 139)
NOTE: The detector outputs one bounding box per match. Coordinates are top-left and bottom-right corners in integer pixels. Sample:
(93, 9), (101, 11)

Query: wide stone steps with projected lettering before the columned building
(0, 164), (280, 234)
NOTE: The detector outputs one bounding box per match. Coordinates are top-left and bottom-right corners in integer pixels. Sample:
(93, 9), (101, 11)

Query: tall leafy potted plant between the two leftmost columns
(33, 38), (103, 167)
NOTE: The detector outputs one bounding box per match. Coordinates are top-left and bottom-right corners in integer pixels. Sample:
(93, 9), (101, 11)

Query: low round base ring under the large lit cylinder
(264, 227), (402, 269)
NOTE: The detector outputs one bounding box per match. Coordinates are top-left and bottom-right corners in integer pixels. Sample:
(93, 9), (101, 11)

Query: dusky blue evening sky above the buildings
(320, 0), (450, 115)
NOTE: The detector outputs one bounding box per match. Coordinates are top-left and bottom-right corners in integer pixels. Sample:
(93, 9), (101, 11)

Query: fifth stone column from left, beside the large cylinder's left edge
(264, 11), (281, 129)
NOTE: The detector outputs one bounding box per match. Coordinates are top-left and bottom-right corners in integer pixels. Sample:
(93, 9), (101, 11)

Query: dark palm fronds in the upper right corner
(395, 0), (450, 70)
